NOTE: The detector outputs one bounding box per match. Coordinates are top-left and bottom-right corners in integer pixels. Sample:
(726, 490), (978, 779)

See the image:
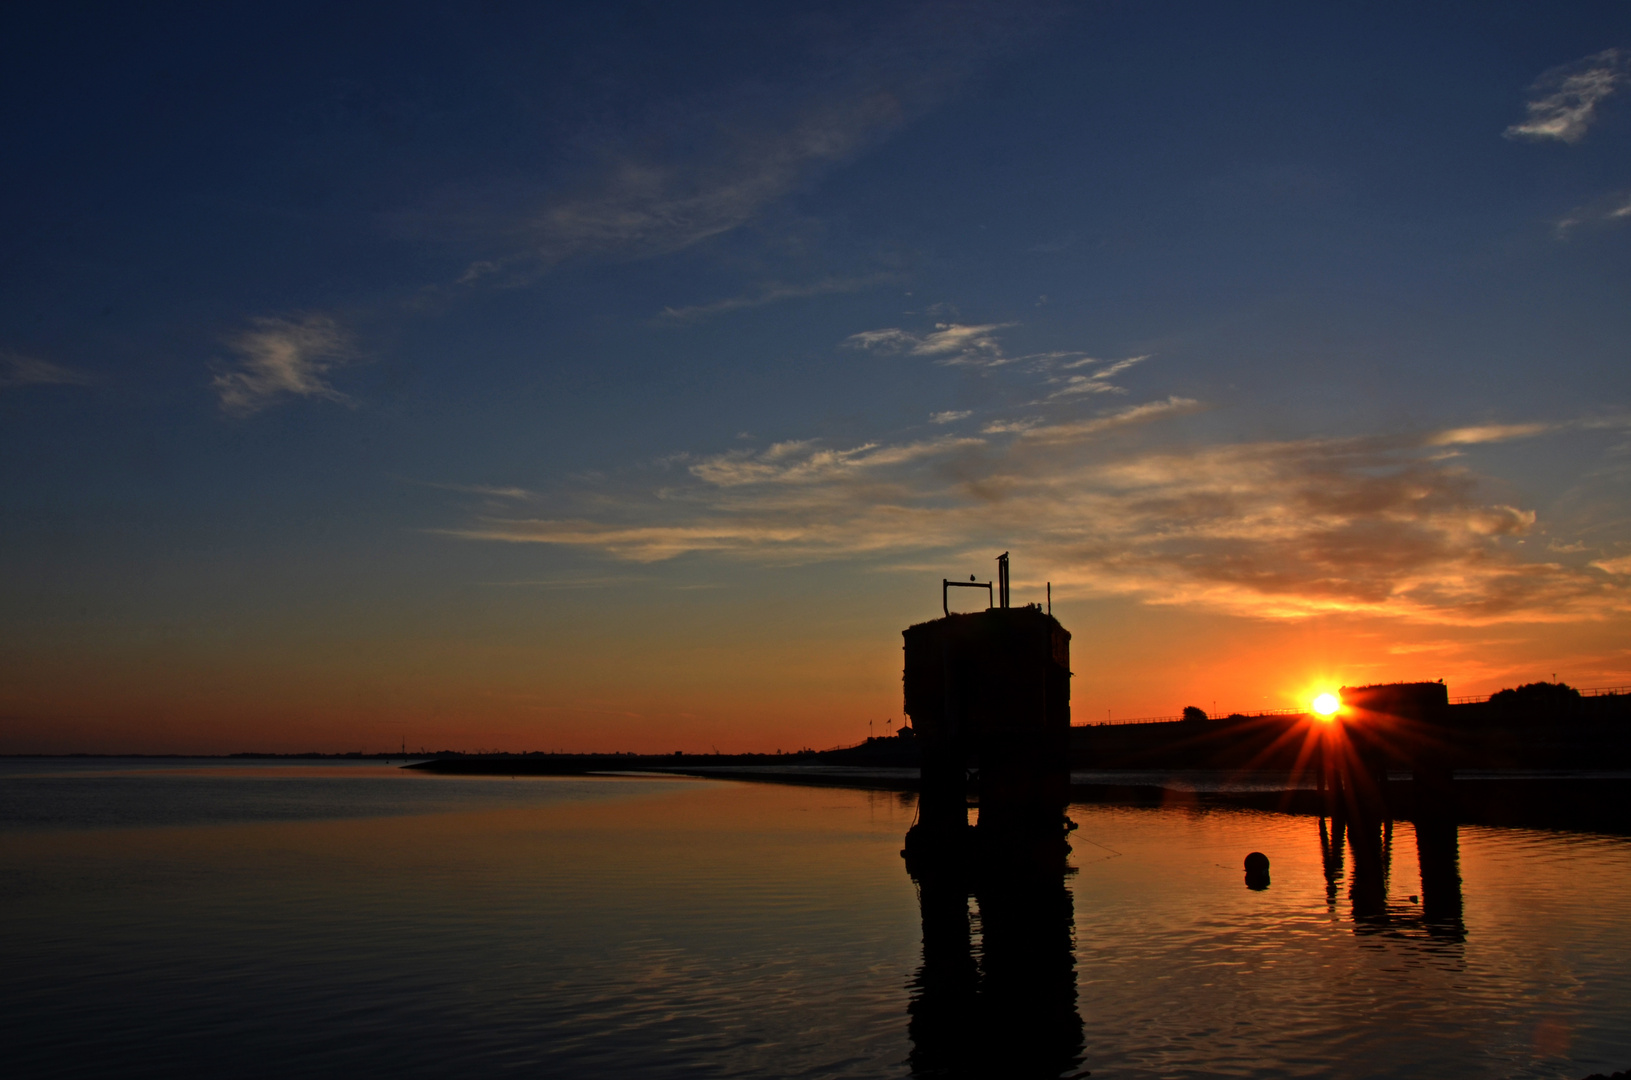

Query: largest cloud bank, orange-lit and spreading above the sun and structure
(449, 404), (1631, 625)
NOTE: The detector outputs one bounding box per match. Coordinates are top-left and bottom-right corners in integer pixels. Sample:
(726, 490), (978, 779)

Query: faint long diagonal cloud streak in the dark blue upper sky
(420, 0), (1065, 284)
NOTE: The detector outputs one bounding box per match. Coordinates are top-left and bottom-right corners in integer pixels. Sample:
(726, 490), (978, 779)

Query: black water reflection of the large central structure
(907, 852), (1083, 1080)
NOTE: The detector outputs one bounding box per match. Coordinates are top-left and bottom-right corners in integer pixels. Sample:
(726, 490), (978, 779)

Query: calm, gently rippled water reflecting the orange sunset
(0, 762), (1631, 1080)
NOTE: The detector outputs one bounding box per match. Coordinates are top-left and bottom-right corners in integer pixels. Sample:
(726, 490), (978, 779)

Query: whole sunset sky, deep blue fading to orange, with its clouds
(0, 0), (1631, 752)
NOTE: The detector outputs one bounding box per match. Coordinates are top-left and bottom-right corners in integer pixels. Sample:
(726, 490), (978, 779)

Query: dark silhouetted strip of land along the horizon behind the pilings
(404, 678), (1631, 834)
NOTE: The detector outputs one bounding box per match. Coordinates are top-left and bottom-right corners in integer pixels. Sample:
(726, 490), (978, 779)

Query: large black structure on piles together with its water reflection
(902, 553), (1085, 1078)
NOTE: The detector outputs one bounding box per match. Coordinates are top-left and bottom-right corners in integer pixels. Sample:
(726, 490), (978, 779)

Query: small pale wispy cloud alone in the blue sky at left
(210, 315), (352, 416)
